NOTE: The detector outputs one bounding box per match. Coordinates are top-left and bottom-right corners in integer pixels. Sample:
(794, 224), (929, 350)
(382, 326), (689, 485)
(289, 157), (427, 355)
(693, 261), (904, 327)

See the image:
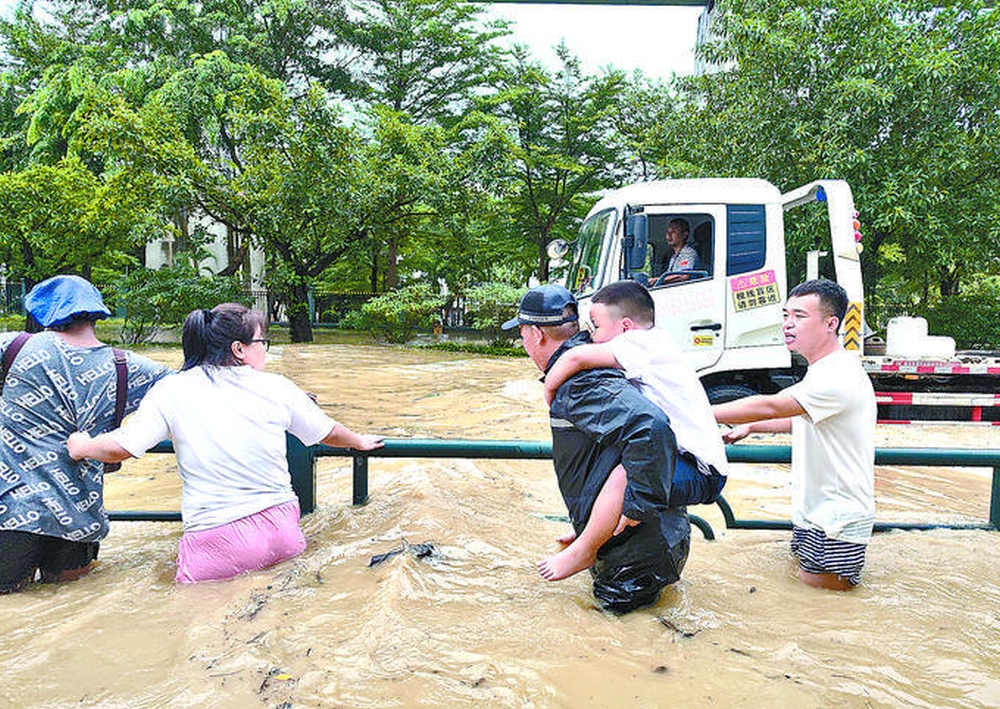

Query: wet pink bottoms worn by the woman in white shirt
(174, 500), (306, 583)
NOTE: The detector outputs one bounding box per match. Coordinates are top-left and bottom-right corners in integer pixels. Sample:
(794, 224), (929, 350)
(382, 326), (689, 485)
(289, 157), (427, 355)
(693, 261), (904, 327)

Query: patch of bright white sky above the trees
(0, 0), (702, 78)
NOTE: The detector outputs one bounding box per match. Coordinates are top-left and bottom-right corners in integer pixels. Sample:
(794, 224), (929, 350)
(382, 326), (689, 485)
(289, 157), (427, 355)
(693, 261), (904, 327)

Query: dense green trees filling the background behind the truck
(0, 0), (1000, 340)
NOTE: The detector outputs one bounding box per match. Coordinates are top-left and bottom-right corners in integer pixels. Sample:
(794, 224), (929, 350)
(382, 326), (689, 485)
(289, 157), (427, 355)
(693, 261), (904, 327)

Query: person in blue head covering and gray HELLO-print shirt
(0, 276), (172, 593)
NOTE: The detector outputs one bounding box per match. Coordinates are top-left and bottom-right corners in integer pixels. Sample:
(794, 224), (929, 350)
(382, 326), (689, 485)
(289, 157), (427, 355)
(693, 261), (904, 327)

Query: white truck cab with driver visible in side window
(567, 179), (862, 401)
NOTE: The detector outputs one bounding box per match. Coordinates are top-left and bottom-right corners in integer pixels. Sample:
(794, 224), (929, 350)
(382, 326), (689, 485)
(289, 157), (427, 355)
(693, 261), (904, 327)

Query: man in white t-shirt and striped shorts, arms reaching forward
(714, 280), (876, 591)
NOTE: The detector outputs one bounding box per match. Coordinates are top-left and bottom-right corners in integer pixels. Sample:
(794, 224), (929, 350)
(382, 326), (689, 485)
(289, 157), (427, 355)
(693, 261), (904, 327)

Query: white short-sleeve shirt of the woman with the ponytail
(112, 366), (336, 531)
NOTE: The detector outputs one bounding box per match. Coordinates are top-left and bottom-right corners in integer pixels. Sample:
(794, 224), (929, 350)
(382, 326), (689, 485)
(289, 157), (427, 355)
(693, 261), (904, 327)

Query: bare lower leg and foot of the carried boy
(538, 465), (626, 581)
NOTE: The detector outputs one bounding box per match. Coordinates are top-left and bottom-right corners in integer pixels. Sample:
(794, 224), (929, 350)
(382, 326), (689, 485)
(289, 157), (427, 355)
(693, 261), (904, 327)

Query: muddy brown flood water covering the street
(0, 345), (1000, 709)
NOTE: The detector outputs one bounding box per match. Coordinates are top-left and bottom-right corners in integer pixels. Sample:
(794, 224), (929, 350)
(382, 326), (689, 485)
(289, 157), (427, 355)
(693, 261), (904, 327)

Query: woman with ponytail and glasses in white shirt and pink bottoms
(67, 303), (382, 583)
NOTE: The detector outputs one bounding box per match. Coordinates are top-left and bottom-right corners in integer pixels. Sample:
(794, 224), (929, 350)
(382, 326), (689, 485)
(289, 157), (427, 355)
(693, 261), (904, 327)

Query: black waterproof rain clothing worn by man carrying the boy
(546, 333), (691, 613)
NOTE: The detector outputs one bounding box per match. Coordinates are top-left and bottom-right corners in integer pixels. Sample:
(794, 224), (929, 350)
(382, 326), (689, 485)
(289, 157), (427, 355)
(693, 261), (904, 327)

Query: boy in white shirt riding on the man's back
(538, 281), (728, 581)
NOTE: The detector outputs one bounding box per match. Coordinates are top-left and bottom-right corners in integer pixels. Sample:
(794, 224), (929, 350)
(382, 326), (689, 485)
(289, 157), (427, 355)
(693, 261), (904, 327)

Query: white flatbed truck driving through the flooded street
(554, 178), (1000, 425)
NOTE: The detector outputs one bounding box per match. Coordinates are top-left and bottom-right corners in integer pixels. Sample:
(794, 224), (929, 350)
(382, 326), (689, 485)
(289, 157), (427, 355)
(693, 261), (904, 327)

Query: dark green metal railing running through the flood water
(109, 436), (1000, 539)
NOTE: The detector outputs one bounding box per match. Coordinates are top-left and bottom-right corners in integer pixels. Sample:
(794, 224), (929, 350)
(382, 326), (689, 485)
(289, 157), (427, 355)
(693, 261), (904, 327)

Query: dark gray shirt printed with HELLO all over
(0, 332), (172, 542)
